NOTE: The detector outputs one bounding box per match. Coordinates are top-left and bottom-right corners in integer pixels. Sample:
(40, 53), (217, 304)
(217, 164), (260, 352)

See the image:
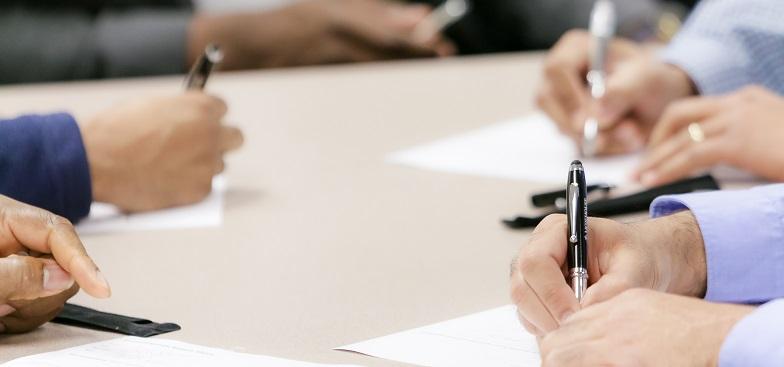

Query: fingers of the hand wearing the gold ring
(633, 120), (725, 186)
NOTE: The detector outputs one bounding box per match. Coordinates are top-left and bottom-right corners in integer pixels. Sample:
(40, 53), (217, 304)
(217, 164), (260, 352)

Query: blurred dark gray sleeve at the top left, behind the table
(0, 7), (192, 83)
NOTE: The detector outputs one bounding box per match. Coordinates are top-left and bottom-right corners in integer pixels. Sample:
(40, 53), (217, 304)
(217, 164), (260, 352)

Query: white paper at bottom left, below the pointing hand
(2, 337), (362, 367)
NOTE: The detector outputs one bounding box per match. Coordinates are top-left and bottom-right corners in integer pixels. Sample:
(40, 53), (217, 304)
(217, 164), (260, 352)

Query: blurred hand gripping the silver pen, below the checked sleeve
(537, 31), (694, 154)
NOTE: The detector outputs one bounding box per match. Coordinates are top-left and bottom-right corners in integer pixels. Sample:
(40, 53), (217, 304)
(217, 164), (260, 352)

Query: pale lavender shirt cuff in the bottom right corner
(719, 300), (784, 367)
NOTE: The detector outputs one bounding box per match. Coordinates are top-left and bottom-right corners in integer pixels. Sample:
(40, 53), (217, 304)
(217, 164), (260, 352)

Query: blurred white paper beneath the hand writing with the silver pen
(387, 114), (639, 184)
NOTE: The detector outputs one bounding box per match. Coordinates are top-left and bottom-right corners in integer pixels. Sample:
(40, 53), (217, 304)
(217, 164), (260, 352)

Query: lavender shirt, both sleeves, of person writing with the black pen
(651, 188), (784, 367)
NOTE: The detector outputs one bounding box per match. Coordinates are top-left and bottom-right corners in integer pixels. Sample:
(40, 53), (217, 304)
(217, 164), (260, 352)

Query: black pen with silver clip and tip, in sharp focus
(566, 161), (588, 302)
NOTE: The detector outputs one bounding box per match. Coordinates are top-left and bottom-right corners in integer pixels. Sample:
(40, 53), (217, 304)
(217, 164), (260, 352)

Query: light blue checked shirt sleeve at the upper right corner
(661, 0), (784, 95)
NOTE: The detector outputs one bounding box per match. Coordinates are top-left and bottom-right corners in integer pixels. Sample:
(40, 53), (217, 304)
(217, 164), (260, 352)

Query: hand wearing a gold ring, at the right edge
(633, 87), (784, 186)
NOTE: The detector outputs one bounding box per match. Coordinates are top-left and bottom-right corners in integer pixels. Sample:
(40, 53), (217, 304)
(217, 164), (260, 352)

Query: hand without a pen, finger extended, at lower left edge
(0, 196), (111, 333)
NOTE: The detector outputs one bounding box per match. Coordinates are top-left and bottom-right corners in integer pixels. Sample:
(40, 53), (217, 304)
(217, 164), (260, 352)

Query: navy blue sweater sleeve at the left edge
(0, 113), (92, 222)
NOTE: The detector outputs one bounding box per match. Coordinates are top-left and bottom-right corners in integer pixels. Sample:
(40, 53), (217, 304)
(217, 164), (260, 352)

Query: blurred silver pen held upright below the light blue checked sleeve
(582, 0), (616, 157)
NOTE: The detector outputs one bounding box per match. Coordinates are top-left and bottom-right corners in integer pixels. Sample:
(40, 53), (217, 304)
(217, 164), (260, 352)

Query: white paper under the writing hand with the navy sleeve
(76, 176), (226, 235)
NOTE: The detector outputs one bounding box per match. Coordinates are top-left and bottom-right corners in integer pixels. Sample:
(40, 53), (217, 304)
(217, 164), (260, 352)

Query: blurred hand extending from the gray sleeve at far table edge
(188, 0), (455, 70)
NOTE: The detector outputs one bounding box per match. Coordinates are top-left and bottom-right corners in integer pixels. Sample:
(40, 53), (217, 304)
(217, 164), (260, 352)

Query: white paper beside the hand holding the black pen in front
(336, 306), (540, 367)
